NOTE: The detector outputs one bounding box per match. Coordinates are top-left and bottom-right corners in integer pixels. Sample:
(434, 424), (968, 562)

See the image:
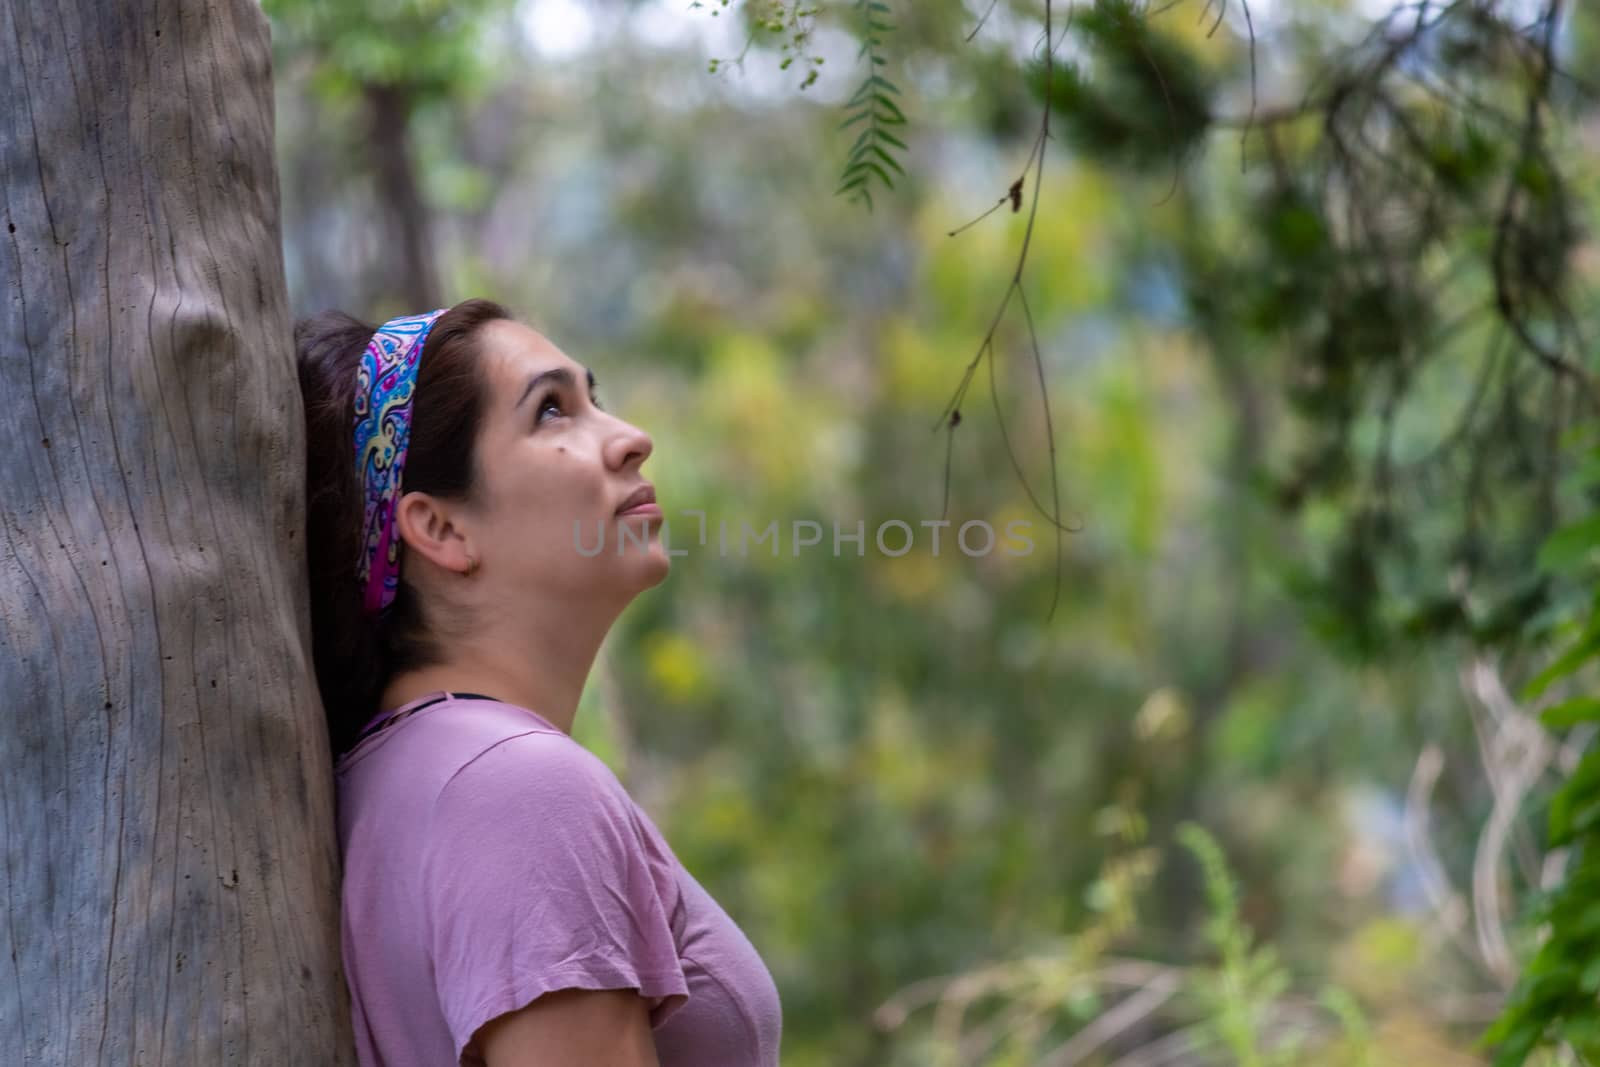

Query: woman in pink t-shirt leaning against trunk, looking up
(294, 301), (781, 1067)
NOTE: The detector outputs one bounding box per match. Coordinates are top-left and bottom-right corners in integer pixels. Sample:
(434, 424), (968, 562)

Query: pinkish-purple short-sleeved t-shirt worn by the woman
(336, 694), (782, 1067)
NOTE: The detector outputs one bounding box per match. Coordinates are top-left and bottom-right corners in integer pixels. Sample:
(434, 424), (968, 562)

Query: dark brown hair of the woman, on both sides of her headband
(294, 299), (512, 753)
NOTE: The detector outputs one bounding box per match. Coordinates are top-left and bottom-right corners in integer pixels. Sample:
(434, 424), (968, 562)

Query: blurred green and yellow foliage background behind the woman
(266, 0), (1600, 1067)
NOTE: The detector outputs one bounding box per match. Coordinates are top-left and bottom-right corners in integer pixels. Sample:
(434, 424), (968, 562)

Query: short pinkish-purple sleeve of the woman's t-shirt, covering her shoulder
(422, 733), (688, 1059)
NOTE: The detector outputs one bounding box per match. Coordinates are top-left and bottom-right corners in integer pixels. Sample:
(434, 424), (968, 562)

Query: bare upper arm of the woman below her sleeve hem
(469, 989), (659, 1067)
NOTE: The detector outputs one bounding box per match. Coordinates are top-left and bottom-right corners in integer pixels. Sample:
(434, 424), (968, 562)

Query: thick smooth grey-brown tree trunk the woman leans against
(0, 0), (354, 1067)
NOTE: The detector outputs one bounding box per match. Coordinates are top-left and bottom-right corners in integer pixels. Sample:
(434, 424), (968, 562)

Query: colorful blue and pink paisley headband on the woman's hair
(355, 307), (450, 616)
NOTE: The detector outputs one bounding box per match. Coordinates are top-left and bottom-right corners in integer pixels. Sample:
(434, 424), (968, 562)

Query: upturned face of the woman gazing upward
(464, 320), (670, 603)
